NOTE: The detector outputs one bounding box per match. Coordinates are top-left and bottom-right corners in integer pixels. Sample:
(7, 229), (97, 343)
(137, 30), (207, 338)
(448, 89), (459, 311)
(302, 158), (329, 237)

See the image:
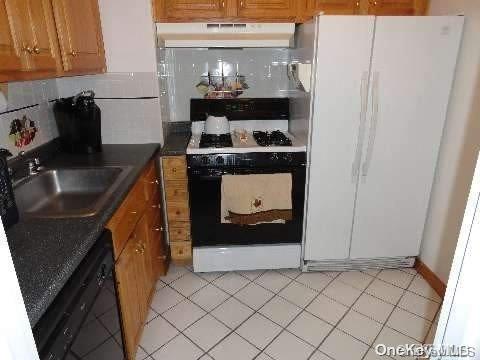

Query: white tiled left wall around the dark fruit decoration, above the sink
(0, 80), (58, 156)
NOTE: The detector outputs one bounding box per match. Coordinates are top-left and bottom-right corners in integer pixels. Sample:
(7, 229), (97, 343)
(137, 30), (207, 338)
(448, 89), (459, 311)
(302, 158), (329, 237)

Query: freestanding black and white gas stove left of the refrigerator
(187, 98), (306, 272)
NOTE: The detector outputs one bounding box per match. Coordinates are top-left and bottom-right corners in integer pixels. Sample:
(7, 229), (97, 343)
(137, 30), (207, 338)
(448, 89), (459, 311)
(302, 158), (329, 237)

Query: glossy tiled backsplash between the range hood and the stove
(158, 48), (289, 121)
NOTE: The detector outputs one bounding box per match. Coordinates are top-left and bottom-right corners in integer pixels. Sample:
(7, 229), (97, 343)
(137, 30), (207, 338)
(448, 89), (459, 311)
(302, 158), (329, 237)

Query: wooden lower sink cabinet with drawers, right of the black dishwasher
(107, 161), (169, 360)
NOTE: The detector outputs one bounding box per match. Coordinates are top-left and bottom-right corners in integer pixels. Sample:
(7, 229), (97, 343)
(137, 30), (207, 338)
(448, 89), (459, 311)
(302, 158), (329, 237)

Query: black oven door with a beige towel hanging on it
(189, 167), (305, 247)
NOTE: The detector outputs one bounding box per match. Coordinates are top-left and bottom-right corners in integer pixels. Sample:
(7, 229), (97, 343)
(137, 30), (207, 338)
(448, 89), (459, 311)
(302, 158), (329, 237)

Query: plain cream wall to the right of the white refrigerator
(420, 0), (480, 282)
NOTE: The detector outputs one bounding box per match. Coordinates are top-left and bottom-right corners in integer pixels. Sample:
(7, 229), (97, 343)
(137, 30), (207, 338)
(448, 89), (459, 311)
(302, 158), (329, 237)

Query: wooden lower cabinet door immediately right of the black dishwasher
(115, 241), (142, 359)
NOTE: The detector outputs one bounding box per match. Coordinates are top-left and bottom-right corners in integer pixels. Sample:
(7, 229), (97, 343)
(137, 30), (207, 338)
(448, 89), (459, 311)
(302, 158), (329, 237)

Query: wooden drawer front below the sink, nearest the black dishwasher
(107, 182), (145, 258)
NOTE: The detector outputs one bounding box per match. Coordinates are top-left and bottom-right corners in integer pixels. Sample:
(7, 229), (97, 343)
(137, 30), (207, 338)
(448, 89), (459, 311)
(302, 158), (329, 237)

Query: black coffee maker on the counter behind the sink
(53, 90), (102, 154)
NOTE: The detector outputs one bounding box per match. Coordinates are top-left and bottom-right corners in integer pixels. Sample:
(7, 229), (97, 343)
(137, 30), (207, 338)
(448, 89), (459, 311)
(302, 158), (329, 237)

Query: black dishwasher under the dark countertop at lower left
(33, 230), (125, 360)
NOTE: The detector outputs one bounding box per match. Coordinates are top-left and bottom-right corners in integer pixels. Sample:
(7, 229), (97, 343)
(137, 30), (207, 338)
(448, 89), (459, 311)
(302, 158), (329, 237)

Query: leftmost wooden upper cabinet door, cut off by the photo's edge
(0, 1), (22, 72)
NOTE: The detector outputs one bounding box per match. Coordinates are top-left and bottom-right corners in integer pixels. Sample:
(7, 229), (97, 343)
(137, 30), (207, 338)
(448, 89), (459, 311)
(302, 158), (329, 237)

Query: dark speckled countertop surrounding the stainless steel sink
(7, 144), (159, 327)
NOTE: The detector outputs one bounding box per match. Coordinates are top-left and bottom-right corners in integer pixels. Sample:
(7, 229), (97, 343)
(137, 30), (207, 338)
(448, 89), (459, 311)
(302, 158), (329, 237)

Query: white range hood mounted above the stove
(157, 23), (295, 48)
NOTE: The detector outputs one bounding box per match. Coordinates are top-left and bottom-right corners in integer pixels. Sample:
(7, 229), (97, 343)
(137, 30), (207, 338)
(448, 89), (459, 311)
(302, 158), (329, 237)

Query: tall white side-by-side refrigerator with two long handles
(293, 16), (464, 270)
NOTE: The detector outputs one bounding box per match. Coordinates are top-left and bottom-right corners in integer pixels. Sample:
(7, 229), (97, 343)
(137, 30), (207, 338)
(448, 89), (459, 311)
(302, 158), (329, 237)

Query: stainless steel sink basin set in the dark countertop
(14, 167), (131, 218)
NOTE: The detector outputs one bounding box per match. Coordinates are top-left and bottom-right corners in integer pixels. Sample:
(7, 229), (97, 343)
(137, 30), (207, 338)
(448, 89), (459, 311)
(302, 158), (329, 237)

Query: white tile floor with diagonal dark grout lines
(137, 266), (441, 360)
